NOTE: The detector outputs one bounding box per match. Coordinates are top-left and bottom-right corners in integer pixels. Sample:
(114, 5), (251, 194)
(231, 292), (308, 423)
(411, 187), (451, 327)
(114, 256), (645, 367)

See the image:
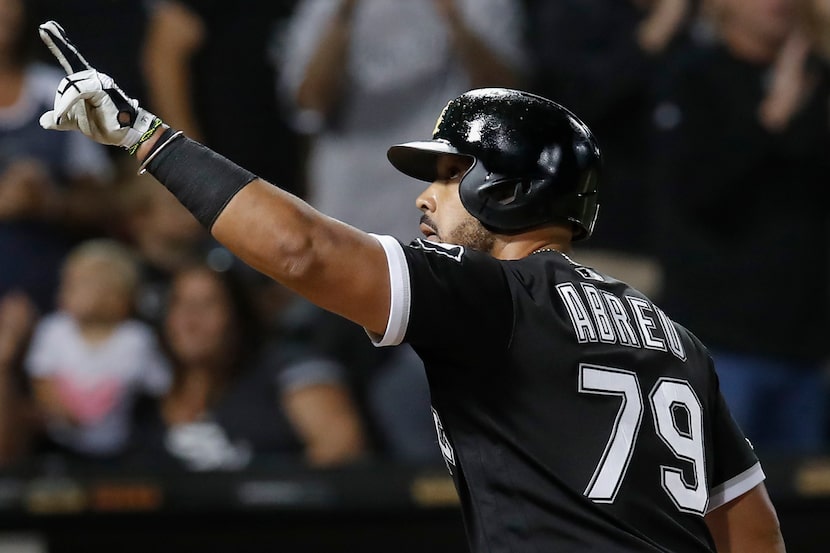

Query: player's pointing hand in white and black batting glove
(40, 21), (161, 153)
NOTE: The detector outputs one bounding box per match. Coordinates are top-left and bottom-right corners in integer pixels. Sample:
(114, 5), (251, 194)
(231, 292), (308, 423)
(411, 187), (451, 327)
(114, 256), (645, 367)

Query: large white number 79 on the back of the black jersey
(579, 364), (709, 514)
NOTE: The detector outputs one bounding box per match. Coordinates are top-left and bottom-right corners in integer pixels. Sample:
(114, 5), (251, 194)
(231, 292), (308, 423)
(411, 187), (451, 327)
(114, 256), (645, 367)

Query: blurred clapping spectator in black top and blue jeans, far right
(652, 0), (830, 451)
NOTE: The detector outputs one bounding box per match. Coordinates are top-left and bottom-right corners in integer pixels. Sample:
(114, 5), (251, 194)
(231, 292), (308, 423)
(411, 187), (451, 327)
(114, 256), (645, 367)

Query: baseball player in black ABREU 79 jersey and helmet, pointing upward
(35, 22), (784, 553)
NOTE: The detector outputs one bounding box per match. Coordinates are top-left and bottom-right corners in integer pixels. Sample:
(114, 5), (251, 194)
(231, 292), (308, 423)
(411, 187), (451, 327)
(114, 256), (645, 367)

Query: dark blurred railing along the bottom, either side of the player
(0, 456), (830, 553)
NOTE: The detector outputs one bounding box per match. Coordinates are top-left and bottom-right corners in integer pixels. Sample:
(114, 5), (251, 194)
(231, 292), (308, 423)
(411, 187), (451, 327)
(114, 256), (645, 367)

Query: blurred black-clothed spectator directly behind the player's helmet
(528, 0), (696, 294)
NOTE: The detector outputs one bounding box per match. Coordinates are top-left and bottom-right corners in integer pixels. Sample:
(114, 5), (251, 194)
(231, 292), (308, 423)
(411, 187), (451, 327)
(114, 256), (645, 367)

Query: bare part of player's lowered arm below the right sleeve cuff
(705, 483), (785, 553)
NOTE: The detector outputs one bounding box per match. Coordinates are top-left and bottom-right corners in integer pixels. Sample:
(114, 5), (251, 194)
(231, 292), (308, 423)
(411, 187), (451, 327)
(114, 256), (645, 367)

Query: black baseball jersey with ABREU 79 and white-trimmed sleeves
(376, 236), (764, 553)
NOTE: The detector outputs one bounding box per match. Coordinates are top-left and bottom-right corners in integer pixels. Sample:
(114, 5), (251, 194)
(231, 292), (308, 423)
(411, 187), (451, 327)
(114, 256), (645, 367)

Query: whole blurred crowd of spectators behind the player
(0, 0), (830, 470)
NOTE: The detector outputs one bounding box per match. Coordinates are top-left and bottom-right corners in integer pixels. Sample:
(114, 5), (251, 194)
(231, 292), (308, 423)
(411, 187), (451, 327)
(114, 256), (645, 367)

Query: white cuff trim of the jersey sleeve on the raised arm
(366, 234), (411, 347)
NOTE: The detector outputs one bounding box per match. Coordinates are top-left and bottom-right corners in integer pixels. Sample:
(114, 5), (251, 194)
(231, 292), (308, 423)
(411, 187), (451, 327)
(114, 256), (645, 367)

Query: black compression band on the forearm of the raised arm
(145, 135), (257, 230)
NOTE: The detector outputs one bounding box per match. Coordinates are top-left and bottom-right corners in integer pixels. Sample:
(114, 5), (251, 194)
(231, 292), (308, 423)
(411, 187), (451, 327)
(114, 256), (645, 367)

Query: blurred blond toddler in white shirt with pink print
(25, 239), (170, 459)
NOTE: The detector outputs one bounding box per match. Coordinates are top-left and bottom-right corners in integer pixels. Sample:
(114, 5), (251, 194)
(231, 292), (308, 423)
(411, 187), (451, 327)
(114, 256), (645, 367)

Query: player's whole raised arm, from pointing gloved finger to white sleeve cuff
(40, 22), (398, 334)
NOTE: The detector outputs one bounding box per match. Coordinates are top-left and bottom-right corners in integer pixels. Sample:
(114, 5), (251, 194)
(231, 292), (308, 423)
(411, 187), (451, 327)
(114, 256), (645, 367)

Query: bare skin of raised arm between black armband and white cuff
(212, 179), (391, 334)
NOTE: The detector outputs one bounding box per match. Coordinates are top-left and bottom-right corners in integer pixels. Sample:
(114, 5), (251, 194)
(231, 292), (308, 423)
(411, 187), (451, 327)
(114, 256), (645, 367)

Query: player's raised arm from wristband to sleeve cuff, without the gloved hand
(137, 132), (390, 334)
